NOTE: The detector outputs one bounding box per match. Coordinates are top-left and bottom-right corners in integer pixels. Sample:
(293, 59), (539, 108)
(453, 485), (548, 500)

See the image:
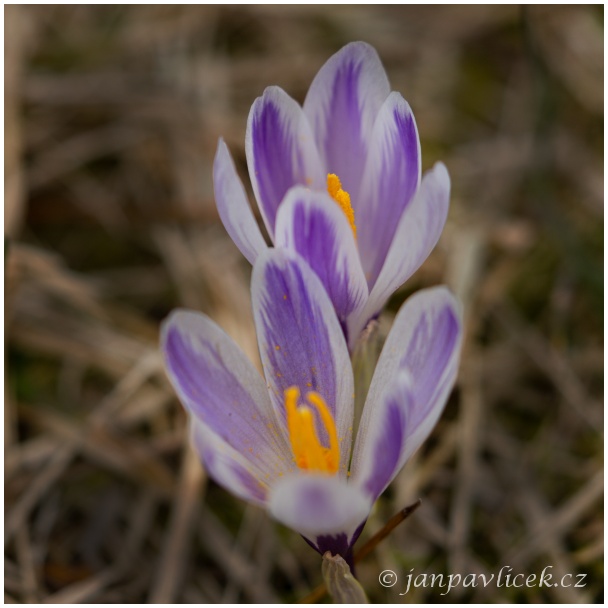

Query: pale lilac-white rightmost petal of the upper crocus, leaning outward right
(349, 163), (450, 346)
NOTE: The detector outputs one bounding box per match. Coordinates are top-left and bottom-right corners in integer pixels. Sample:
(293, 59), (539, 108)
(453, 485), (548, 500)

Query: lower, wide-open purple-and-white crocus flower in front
(162, 249), (462, 561)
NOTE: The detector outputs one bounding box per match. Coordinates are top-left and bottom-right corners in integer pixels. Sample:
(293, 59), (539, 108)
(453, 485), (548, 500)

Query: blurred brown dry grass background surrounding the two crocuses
(4, 5), (604, 603)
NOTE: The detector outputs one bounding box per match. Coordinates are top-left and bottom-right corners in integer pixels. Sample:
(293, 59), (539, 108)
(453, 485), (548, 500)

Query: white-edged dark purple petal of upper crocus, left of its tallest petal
(245, 87), (327, 238)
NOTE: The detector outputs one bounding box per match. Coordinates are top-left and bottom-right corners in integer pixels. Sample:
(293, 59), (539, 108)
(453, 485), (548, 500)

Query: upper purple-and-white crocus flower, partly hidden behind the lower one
(213, 42), (450, 350)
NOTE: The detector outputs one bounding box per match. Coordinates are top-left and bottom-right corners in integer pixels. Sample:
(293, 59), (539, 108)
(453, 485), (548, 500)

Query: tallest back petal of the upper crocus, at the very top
(304, 42), (390, 196)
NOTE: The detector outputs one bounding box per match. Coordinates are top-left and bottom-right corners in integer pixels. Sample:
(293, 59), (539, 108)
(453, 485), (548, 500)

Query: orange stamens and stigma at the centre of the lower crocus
(285, 386), (340, 474)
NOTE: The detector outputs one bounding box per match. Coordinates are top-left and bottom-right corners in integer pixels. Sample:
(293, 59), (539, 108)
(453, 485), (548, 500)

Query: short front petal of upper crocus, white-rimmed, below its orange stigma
(275, 186), (369, 327)
